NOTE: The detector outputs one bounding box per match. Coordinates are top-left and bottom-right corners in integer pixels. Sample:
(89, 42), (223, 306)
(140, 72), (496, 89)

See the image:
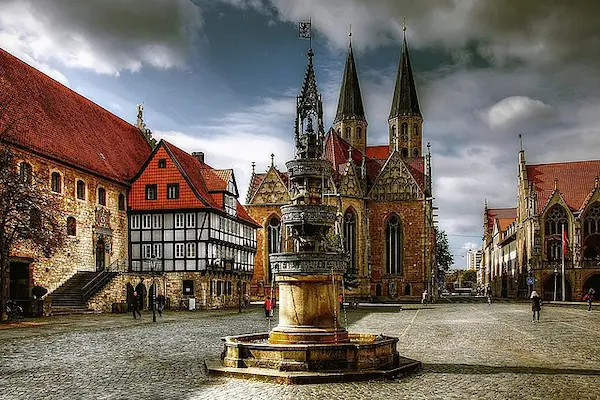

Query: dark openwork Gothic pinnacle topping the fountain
(294, 49), (325, 158)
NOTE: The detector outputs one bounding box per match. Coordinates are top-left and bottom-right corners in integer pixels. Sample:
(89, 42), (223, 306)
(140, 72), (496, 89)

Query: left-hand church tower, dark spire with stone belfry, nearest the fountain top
(333, 35), (367, 154)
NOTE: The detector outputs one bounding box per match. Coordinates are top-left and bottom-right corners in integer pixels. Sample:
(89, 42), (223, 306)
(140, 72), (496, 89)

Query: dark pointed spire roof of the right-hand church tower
(390, 32), (422, 119)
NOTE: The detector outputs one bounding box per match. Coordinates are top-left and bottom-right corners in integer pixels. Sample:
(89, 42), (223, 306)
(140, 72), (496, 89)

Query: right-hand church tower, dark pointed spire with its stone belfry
(388, 27), (423, 157)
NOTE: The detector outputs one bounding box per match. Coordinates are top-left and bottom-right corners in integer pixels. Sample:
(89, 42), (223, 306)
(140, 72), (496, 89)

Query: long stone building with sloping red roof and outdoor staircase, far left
(0, 49), (151, 310)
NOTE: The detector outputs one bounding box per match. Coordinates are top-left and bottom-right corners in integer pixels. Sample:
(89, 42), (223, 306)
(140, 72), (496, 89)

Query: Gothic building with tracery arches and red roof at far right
(484, 150), (600, 300)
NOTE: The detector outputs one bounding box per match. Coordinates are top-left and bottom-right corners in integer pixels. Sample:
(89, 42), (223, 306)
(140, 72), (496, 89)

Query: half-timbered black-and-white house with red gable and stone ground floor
(123, 140), (258, 308)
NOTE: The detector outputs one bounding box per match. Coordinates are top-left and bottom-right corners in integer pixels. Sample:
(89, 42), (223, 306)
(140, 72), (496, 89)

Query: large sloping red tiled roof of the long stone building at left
(0, 49), (151, 183)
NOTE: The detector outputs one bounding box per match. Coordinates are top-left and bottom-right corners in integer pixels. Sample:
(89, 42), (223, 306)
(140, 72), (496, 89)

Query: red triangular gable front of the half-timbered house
(128, 142), (206, 211)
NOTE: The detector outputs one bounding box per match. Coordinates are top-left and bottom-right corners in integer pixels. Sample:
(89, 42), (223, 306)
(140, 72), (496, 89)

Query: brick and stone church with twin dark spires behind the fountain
(246, 33), (437, 300)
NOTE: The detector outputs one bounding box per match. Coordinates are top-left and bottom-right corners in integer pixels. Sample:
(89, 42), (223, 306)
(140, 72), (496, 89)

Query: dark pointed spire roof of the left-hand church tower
(333, 43), (365, 124)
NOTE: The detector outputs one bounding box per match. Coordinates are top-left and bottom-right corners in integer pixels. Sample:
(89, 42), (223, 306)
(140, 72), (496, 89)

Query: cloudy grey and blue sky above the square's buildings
(0, 0), (600, 267)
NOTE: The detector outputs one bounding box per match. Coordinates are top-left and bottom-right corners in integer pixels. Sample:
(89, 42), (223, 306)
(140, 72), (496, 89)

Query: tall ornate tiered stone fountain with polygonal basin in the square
(206, 50), (421, 383)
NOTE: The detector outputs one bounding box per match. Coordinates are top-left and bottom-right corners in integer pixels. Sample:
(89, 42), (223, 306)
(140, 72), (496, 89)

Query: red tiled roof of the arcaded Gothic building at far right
(527, 160), (600, 213)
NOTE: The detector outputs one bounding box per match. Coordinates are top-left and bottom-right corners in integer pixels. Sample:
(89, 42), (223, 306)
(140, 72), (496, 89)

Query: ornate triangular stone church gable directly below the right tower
(369, 151), (423, 201)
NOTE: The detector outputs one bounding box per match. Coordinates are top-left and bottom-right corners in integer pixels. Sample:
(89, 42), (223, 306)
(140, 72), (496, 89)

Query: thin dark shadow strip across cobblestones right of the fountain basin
(422, 363), (600, 375)
